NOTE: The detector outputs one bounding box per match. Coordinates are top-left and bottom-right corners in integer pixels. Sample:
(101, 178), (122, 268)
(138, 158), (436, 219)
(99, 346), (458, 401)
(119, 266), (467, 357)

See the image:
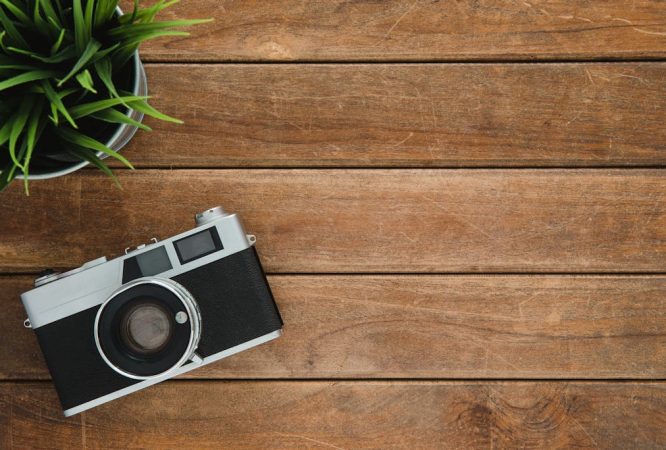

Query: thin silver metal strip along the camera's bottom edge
(64, 330), (282, 417)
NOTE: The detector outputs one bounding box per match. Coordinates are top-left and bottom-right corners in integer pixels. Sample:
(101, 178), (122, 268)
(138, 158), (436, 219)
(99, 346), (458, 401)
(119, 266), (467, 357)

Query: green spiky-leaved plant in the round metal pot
(0, 0), (207, 194)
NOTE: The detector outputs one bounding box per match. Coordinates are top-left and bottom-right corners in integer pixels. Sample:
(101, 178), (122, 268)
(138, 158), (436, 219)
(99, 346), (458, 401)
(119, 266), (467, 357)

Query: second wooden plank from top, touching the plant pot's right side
(113, 63), (666, 167)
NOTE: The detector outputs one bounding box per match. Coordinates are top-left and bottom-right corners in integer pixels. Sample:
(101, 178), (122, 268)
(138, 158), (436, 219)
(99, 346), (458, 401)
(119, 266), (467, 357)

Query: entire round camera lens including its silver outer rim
(95, 278), (201, 380)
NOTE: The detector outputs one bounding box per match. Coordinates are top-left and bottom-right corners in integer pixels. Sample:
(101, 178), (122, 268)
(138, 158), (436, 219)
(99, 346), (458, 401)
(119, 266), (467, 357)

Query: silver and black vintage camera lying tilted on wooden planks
(21, 207), (282, 416)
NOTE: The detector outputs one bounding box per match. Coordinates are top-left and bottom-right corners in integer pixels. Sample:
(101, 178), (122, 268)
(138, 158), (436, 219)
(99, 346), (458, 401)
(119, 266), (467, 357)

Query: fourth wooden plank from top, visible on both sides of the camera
(0, 276), (666, 380)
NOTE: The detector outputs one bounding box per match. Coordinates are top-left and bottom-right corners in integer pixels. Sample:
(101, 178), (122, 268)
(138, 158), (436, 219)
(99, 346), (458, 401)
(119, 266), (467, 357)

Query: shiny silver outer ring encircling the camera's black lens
(94, 277), (201, 380)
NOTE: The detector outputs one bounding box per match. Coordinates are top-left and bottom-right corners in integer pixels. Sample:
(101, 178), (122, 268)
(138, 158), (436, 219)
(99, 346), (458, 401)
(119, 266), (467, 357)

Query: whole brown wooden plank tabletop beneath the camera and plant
(0, 0), (666, 449)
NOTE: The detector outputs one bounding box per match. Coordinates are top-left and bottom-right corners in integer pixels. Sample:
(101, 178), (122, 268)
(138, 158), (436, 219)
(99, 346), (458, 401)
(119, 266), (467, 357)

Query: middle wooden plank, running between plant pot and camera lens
(0, 169), (666, 273)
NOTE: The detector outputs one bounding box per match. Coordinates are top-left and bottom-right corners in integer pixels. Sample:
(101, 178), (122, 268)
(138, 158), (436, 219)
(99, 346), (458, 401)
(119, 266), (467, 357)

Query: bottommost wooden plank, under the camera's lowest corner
(0, 382), (666, 449)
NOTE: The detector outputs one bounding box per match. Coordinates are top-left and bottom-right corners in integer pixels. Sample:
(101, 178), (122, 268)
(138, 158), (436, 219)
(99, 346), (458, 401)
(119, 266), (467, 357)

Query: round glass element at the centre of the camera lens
(119, 300), (174, 355)
